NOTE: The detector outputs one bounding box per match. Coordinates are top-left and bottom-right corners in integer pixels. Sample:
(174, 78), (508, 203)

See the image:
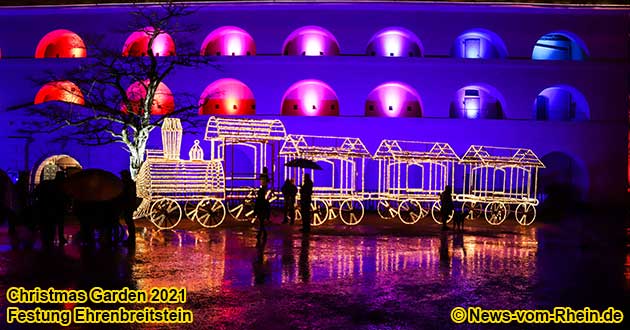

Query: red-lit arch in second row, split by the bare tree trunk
(122, 81), (175, 115)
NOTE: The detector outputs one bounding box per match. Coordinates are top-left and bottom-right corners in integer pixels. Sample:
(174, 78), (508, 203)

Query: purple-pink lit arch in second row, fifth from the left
(365, 82), (422, 117)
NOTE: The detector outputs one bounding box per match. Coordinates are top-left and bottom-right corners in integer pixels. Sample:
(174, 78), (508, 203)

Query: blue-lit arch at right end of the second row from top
(534, 85), (590, 121)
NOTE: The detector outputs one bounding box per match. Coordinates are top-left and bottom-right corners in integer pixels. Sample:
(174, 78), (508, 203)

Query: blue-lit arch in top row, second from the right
(451, 29), (507, 59)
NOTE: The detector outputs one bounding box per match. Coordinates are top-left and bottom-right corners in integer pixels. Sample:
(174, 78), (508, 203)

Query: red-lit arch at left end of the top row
(35, 29), (87, 58)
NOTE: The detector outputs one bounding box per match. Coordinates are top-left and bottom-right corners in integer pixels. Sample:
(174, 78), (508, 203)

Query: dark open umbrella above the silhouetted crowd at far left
(64, 169), (123, 202)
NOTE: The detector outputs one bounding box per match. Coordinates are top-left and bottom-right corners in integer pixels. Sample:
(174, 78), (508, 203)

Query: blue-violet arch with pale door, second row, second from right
(450, 84), (505, 119)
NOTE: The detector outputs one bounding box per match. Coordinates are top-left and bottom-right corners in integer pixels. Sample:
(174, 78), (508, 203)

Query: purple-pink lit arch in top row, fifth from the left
(367, 27), (423, 57)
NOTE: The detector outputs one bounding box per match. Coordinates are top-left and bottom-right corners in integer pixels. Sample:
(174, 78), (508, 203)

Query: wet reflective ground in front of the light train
(0, 215), (630, 329)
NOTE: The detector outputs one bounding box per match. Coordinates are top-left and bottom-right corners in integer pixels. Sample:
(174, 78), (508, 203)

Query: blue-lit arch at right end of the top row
(532, 31), (588, 61)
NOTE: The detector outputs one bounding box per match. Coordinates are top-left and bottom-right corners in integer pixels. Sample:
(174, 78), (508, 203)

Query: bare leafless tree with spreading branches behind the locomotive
(14, 2), (217, 178)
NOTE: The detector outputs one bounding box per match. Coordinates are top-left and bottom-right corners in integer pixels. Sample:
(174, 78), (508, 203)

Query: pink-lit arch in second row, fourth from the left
(282, 79), (339, 116)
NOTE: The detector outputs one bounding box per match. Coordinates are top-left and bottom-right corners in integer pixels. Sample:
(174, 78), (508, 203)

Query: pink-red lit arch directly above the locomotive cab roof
(199, 78), (256, 115)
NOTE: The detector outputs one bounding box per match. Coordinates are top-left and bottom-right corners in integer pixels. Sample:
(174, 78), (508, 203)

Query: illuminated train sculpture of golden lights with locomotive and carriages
(135, 117), (544, 229)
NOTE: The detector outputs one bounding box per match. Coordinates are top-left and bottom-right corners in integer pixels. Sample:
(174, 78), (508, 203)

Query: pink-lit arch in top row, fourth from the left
(282, 26), (340, 56)
